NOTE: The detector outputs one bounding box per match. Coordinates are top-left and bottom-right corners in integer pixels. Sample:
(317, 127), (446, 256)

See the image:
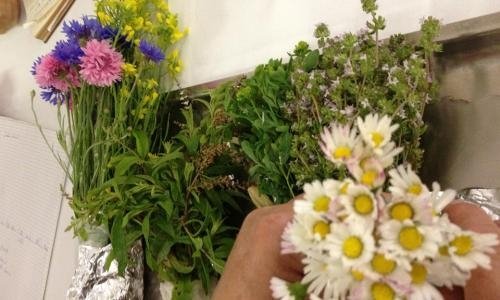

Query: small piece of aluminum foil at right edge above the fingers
(457, 188), (500, 221)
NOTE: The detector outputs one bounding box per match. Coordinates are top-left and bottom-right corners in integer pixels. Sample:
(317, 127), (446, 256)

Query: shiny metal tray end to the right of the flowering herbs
(420, 13), (500, 189)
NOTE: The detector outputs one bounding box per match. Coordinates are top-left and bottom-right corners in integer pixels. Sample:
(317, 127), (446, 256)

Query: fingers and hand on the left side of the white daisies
(212, 201), (303, 300)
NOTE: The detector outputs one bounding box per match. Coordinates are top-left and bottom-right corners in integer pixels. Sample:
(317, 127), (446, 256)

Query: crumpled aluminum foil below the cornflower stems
(67, 242), (144, 300)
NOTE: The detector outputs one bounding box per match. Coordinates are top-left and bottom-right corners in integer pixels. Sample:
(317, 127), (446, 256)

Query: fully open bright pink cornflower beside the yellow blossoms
(80, 39), (123, 86)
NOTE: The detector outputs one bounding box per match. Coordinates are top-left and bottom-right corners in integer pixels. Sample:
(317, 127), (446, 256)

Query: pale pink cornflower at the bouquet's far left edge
(35, 54), (80, 92)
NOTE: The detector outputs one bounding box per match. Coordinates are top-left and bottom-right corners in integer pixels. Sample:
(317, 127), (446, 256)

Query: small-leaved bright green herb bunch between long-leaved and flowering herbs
(220, 60), (293, 202)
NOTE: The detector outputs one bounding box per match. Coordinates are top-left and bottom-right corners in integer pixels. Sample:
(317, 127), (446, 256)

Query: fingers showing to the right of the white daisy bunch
(440, 201), (500, 300)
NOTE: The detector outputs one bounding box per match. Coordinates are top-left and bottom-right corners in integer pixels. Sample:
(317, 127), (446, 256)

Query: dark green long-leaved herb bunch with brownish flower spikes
(80, 94), (249, 299)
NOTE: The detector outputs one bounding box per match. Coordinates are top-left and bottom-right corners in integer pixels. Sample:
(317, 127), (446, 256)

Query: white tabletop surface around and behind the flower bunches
(0, 0), (500, 299)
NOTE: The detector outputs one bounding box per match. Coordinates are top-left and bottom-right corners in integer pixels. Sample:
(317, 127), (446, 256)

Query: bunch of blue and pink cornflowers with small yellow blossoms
(32, 0), (185, 239)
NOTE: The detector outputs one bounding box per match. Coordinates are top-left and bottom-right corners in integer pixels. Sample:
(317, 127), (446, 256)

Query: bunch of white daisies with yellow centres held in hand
(271, 115), (498, 300)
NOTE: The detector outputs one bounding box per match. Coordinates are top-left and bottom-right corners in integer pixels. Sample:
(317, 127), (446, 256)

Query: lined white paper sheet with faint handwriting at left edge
(0, 117), (65, 300)
